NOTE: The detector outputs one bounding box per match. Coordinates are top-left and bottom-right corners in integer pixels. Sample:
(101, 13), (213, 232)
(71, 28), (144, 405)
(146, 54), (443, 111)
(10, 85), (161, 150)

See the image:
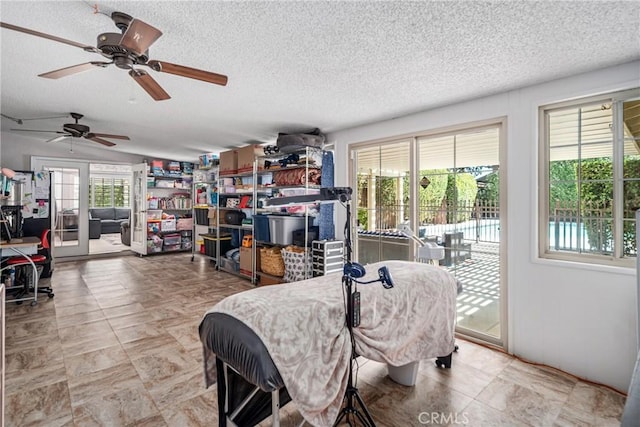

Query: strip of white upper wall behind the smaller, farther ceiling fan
(0, 132), (144, 170)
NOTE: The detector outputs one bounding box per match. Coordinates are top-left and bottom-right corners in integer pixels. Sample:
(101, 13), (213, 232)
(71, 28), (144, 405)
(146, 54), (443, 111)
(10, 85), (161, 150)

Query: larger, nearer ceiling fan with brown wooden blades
(0, 12), (227, 101)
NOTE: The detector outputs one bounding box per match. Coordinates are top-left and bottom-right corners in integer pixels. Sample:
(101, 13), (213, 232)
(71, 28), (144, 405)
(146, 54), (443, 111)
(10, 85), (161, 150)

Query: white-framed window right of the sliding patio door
(540, 89), (640, 266)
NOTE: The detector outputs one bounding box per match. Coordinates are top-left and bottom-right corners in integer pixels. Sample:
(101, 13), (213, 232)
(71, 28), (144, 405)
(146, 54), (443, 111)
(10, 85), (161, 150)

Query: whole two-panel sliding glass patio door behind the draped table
(350, 121), (506, 346)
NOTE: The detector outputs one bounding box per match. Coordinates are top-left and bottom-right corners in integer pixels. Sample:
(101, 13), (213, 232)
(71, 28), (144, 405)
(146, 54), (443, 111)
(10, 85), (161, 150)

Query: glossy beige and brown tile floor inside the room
(5, 254), (625, 427)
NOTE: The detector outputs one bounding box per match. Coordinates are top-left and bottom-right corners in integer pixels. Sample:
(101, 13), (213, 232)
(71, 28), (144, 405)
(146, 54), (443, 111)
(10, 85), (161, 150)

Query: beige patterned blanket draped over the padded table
(205, 261), (457, 426)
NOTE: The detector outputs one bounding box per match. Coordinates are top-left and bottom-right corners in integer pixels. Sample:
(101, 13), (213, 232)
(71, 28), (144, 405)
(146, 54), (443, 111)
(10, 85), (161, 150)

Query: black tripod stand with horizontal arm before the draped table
(264, 187), (393, 427)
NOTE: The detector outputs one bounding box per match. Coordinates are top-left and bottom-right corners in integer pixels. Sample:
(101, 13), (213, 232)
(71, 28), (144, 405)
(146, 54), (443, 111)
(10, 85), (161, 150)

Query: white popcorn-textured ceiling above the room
(0, 0), (640, 160)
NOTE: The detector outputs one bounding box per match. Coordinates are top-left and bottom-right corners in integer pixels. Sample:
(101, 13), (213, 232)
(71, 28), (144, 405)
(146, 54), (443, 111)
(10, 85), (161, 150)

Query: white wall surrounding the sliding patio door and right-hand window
(328, 61), (640, 392)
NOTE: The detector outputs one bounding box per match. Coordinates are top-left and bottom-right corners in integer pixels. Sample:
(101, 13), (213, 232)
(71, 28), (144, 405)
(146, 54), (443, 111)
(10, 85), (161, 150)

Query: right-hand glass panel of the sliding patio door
(415, 125), (502, 342)
